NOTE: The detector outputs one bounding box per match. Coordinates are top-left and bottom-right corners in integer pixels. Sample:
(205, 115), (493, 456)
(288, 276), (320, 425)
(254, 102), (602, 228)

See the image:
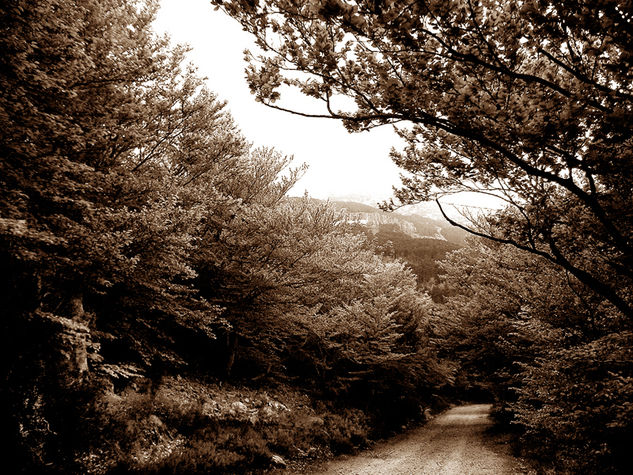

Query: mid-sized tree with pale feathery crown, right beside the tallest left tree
(196, 173), (376, 377)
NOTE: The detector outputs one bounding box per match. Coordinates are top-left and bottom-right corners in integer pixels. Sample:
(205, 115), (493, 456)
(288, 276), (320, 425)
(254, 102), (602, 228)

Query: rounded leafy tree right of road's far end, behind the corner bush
(436, 241), (596, 402)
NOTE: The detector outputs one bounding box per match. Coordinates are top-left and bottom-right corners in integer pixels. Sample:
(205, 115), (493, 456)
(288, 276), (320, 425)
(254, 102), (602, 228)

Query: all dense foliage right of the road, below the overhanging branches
(436, 243), (631, 473)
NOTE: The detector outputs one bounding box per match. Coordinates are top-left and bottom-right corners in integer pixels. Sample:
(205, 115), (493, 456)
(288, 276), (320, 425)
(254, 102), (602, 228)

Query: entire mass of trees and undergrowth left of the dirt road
(0, 0), (451, 473)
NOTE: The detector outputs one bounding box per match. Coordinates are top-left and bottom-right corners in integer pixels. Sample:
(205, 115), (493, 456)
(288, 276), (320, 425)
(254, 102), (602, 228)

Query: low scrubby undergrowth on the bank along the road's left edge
(76, 377), (368, 473)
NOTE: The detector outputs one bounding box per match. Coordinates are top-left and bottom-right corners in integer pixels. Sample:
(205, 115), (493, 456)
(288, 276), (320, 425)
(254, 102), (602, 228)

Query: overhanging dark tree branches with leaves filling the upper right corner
(214, 0), (633, 317)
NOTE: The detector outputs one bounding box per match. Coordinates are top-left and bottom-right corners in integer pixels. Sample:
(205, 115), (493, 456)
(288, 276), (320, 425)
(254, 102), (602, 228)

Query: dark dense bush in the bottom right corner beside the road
(509, 333), (633, 474)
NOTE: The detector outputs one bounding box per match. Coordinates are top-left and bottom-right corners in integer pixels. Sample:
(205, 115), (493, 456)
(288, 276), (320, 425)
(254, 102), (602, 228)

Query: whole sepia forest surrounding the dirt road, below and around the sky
(0, 0), (633, 474)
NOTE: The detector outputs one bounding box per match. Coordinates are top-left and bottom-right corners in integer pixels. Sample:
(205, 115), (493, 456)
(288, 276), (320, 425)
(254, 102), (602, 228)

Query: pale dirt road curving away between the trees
(315, 404), (528, 475)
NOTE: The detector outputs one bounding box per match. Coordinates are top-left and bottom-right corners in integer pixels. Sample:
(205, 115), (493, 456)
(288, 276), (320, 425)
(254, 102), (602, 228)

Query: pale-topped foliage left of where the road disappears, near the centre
(289, 257), (452, 432)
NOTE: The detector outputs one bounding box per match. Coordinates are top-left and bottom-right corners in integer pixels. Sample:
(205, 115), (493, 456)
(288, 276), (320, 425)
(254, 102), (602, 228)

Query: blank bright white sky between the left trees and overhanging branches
(155, 0), (399, 200)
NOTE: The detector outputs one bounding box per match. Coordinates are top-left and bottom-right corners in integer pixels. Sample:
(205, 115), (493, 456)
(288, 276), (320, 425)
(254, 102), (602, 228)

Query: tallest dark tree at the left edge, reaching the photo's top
(0, 0), (248, 471)
